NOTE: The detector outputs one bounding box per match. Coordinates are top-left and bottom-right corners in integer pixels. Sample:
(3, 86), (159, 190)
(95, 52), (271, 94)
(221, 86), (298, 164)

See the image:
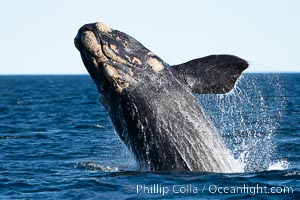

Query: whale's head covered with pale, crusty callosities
(74, 22), (166, 95)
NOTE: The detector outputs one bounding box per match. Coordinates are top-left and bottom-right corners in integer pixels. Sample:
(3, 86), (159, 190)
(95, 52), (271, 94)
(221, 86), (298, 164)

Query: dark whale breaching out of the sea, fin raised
(74, 22), (248, 173)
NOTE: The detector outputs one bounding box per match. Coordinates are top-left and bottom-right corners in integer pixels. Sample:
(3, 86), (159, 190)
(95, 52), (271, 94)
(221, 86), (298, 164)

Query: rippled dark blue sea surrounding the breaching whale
(0, 74), (300, 199)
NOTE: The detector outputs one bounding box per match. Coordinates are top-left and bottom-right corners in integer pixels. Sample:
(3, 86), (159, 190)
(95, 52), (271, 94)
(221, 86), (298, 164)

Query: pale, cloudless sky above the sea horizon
(0, 0), (300, 74)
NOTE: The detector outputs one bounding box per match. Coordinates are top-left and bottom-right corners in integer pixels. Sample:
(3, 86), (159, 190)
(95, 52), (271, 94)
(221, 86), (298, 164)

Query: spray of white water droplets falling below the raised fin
(197, 74), (285, 171)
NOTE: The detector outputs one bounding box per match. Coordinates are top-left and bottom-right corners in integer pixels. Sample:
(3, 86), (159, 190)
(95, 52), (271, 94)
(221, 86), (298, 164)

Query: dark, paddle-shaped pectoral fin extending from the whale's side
(171, 55), (248, 94)
